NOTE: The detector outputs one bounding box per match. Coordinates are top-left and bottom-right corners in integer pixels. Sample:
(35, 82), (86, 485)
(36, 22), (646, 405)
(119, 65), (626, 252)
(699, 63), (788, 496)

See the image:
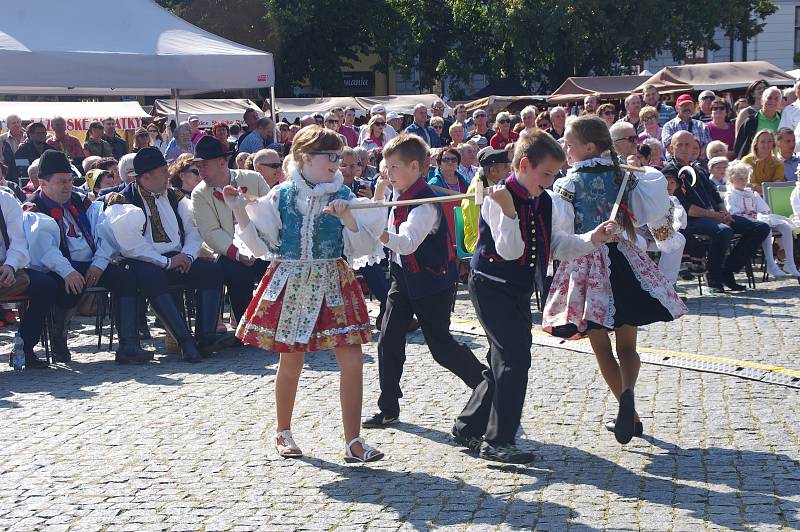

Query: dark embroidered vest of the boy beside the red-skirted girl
(392, 179), (458, 299)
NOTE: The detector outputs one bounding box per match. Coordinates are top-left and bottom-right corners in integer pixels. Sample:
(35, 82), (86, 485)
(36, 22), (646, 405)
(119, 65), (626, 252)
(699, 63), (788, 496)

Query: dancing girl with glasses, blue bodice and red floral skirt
(224, 126), (386, 462)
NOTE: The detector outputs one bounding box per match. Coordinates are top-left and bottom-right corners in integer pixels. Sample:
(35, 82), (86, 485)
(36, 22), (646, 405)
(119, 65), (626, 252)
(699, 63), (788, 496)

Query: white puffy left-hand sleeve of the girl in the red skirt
(236, 187), (283, 260)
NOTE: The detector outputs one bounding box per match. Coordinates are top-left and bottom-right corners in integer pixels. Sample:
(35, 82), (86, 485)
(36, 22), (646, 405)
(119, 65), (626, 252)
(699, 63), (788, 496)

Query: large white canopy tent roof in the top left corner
(0, 0), (275, 95)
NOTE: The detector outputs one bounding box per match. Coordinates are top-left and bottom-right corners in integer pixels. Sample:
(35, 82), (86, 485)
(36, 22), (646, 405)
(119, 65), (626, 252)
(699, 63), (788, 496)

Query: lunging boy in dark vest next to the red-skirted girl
(362, 134), (486, 428)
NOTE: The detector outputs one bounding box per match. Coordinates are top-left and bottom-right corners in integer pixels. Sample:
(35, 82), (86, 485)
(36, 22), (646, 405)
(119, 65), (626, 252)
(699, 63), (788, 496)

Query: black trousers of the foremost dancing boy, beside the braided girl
(455, 272), (533, 445)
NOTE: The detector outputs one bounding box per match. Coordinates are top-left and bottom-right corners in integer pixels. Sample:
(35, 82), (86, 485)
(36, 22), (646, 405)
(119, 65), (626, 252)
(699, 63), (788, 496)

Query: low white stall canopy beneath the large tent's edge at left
(0, 102), (150, 131)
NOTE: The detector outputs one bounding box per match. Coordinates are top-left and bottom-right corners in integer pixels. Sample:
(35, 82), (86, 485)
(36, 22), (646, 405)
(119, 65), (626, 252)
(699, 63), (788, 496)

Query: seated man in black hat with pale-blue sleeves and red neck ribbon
(23, 150), (153, 364)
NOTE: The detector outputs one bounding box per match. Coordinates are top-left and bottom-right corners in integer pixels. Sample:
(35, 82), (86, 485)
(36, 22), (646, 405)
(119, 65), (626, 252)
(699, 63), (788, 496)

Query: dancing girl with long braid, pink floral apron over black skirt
(542, 116), (687, 444)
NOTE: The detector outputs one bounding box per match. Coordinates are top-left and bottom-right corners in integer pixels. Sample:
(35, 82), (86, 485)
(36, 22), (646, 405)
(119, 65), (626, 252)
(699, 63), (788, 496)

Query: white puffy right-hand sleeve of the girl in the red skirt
(343, 194), (389, 270)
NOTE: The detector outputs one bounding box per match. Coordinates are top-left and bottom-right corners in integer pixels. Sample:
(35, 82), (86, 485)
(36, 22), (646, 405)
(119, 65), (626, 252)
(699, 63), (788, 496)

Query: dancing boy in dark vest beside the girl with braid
(453, 131), (615, 463)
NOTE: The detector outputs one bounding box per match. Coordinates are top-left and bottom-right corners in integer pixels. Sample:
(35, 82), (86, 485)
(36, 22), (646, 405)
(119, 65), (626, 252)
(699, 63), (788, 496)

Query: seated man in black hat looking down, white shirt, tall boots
(105, 147), (237, 362)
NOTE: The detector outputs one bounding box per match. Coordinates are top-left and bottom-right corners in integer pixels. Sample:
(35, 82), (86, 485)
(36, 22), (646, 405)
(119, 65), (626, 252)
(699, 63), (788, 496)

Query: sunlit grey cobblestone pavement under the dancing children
(0, 272), (800, 531)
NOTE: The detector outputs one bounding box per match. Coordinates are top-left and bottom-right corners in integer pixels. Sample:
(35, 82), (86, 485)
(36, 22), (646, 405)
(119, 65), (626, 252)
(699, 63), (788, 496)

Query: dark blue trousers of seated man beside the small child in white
(684, 215), (771, 284)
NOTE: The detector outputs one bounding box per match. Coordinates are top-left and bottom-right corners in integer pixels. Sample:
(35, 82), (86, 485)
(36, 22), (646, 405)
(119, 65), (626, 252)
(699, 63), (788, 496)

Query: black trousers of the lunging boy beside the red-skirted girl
(378, 263), (485, 417)
